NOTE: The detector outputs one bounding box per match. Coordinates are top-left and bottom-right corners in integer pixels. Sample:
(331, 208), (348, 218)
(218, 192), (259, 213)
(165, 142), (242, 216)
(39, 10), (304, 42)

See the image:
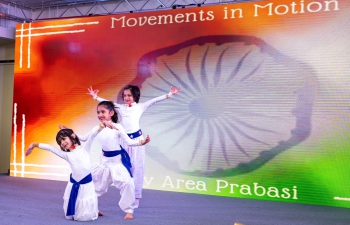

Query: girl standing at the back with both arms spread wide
(88, 85), (180, 208)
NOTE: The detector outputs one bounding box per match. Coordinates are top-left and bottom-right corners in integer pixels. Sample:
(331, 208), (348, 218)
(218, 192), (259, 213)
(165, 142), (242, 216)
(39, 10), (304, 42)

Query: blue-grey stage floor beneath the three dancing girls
(0, 175), (350, 225)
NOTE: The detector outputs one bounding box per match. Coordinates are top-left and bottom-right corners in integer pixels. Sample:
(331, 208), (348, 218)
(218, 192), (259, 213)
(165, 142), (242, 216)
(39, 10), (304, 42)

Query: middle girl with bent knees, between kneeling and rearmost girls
(78, 101), (150, 219)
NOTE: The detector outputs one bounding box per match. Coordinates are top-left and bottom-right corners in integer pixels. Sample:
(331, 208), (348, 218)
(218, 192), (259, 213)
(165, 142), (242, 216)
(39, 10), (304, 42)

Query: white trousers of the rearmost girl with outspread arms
(120, 135), (145, 198)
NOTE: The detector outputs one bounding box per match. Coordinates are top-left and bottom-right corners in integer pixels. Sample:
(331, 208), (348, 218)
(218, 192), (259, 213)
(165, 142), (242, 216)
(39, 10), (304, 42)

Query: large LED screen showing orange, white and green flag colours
(11, 0), (350, 208)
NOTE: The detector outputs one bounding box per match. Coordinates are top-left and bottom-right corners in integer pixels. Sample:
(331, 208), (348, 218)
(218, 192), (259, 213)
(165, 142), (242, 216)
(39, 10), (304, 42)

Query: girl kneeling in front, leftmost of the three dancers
(26, 121), (115, 221)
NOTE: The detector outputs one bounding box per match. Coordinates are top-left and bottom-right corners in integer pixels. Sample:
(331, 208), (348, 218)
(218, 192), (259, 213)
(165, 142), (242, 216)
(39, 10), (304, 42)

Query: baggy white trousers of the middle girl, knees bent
(91, 155), (135, 213)
